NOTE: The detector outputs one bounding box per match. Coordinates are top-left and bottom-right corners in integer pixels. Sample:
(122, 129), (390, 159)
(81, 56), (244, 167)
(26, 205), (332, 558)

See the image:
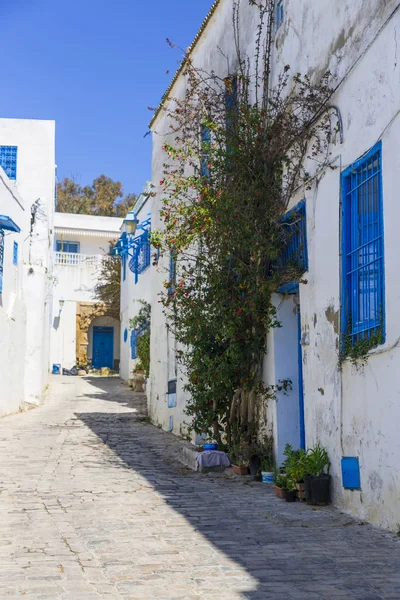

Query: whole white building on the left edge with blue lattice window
(0, 119), (55, 415)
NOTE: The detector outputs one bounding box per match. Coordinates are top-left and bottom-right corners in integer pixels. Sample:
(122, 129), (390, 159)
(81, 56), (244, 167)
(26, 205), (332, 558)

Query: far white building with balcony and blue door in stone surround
(50, 213), (122, 370)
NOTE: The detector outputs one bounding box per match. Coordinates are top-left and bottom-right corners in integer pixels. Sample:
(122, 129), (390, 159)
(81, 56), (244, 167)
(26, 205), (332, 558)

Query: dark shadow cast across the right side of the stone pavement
(76, 378), (400, 600)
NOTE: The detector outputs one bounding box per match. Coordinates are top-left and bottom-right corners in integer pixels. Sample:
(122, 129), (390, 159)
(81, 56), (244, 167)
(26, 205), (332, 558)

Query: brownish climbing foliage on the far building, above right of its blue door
(94, 256), (121, 321)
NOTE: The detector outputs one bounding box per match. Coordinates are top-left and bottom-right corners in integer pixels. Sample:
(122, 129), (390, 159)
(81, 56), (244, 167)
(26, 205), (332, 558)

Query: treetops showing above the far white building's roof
(56, 175), (137, 217)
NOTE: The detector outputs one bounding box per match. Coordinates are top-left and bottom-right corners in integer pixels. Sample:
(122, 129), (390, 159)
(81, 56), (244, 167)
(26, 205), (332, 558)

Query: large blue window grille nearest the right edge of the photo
(342, 142), (385, 344)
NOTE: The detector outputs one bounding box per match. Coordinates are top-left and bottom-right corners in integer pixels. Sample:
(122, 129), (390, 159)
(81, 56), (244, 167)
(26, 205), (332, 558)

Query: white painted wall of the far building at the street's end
(50, 213), (122, 369)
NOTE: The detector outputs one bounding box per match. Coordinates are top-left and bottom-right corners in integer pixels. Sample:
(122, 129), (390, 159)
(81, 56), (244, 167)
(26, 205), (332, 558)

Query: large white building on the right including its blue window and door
(150, 0), (400, 528)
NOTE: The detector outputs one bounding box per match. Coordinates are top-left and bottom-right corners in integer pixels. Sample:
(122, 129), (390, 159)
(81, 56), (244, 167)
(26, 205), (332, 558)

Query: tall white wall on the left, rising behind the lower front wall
(0, 119), (55, 403)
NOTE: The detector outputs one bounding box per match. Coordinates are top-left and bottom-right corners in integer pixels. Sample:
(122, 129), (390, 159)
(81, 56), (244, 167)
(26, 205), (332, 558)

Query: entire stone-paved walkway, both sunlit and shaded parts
(0, 377), (400, 600)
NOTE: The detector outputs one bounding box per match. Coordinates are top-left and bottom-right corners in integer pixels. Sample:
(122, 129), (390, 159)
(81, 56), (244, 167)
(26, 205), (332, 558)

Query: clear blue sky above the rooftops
(0, 0), (213, 193)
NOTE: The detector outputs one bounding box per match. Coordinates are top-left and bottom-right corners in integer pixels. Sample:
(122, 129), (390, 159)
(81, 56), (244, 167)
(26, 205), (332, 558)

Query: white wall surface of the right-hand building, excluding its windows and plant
(149, 0), (400, 528)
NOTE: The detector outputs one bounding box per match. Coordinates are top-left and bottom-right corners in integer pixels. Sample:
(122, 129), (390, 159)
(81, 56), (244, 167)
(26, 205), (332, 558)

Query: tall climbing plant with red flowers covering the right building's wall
(152, 0), (333, 446)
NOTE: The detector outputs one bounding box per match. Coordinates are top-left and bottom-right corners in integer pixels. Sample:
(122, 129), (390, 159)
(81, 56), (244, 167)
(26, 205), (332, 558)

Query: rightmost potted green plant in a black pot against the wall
(304, 442), (331, 505)
